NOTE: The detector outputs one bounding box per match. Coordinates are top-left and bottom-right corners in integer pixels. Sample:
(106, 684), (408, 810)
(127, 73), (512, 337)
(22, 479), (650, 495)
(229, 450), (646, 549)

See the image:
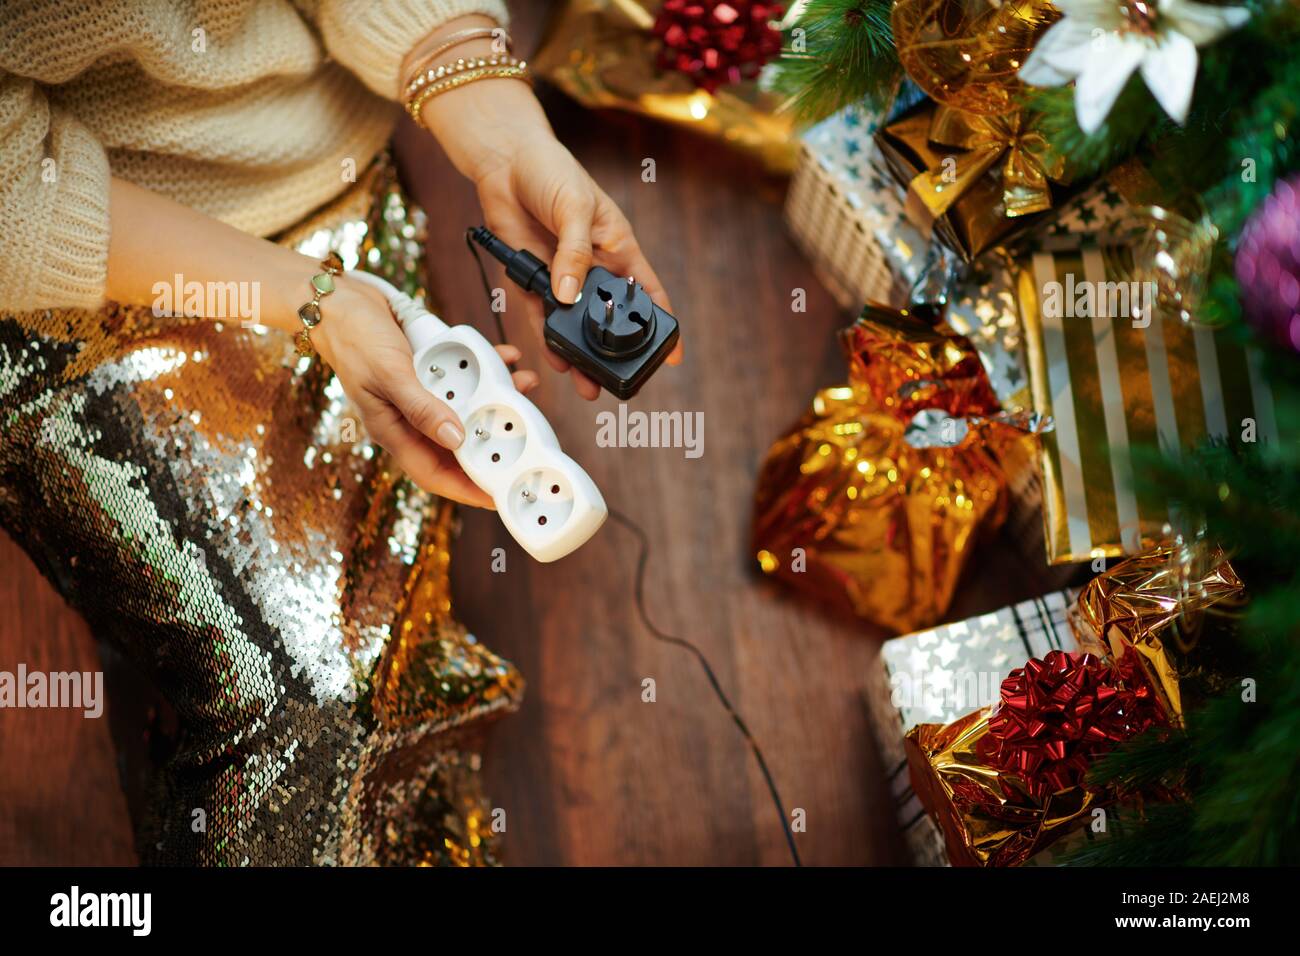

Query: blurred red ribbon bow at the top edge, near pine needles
(654, 0), (784, 92)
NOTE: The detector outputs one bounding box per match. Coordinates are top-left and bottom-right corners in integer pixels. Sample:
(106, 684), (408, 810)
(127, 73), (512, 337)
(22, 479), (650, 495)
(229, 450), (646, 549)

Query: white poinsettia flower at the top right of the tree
(1019, 0), (1251, 134)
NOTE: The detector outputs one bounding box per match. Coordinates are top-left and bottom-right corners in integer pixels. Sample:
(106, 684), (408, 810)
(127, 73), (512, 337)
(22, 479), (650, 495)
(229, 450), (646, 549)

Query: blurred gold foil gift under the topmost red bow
(532, 0), (798, 173)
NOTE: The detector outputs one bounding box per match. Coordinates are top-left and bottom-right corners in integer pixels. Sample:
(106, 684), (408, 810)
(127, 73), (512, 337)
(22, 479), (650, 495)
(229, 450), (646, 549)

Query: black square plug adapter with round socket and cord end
(468, 226), (679, 399)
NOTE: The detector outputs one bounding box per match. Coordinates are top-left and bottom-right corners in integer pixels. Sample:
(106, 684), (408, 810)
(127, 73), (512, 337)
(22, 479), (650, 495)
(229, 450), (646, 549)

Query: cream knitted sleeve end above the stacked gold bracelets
(317, 0), (508, 100)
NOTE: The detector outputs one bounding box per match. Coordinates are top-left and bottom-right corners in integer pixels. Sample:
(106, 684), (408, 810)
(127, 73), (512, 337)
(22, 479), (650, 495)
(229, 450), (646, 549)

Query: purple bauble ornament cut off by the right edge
(1236, 177), (1300, 352)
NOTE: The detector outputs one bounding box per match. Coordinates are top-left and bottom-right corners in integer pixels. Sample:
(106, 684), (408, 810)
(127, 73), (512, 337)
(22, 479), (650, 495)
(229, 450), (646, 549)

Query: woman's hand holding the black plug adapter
(423, 44), (683, 399)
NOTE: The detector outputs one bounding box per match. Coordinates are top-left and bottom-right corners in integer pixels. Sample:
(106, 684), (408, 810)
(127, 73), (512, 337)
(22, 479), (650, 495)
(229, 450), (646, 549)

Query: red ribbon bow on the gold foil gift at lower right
(980, 650), (1158, 800)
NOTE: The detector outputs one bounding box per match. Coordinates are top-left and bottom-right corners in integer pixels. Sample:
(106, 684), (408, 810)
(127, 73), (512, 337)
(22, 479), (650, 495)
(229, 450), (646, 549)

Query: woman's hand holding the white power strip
(312, 276), (538, 509)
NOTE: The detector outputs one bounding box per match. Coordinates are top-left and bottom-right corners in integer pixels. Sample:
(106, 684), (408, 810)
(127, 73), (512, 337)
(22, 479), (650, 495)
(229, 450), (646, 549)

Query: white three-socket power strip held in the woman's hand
(348, 272), (610, 562)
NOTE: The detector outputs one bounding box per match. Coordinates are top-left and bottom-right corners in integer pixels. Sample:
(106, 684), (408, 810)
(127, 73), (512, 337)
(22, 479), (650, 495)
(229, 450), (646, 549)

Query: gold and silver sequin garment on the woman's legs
(0, 159), (523, 865)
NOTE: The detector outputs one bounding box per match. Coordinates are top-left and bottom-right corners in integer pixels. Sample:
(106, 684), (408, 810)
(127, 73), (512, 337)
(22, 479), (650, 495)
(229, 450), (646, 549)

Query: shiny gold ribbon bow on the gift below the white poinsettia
(910, 107), (1065, 219)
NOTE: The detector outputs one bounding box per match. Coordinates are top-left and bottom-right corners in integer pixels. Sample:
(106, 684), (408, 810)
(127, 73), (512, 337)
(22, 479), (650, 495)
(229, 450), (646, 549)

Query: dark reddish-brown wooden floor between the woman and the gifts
(0, 5), (1076, 865)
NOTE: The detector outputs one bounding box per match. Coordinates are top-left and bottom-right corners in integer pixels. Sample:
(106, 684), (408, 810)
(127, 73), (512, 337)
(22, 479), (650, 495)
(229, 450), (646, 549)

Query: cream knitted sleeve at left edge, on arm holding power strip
(0, 72), (109, 312)
